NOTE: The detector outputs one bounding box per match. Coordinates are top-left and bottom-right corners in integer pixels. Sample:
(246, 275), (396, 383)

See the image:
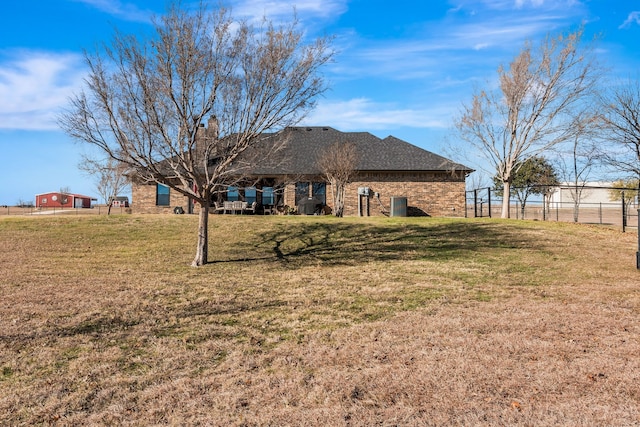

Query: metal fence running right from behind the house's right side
(466, 188), (638, 231)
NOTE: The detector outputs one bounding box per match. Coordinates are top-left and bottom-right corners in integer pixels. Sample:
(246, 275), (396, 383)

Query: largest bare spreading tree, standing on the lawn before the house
(59, 1), (333, 266)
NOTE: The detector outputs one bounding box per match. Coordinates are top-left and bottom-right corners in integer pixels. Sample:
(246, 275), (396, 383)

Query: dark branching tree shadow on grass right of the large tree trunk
(213, 221), (539, 267)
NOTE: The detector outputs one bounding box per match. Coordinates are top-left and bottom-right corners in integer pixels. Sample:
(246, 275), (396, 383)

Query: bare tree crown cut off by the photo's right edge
(601, 80), (640, 192)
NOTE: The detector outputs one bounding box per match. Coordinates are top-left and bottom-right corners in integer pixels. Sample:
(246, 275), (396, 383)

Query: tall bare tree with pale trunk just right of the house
(456, 30), (599, 218)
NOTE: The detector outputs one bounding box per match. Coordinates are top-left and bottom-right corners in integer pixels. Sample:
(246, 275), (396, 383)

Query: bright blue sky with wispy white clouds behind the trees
(0, 0), (640, 205)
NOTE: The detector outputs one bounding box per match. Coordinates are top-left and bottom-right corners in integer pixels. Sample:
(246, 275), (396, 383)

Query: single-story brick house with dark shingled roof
(132, 127), (472, 216)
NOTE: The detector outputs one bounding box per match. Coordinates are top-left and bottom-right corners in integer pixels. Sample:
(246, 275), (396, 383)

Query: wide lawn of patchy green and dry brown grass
(0, 215), (640, 426)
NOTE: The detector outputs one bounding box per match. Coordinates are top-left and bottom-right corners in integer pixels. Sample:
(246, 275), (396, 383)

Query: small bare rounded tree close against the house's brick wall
(318, 142), (358, 217)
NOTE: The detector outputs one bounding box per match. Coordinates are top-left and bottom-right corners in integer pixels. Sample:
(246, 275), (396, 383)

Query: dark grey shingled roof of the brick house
(252, 126), (472, 175)
